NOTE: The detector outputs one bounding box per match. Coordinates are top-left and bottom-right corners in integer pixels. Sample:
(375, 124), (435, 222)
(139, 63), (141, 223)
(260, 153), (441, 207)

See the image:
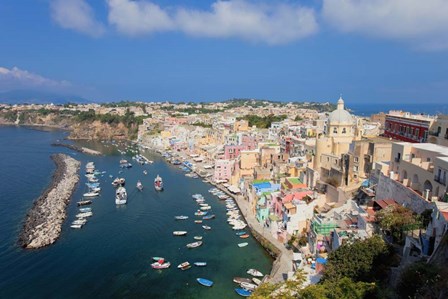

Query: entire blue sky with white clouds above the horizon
(0, 0), (448, 104)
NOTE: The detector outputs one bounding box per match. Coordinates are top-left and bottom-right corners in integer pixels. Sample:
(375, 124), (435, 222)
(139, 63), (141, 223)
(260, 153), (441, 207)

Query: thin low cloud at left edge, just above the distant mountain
(0, 67), (71, 91)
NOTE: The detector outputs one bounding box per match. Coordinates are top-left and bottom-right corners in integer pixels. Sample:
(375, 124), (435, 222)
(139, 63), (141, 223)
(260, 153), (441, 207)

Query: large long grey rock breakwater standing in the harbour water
(19, 154), (81, 249)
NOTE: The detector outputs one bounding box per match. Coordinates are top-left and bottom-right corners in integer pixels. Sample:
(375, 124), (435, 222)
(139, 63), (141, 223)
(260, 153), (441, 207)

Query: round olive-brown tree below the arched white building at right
(376, 206), (422, 242)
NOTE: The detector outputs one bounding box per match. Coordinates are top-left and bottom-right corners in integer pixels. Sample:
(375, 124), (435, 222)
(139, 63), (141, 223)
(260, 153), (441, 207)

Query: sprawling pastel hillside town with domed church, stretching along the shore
(0, 97), (448, 298)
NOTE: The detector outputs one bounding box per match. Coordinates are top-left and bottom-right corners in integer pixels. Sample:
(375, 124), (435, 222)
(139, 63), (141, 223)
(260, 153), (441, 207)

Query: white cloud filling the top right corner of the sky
(322, 0), (448, 49)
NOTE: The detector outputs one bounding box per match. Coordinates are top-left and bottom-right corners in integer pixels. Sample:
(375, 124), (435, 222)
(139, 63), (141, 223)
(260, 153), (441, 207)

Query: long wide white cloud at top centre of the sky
(107, 0), (318, 44)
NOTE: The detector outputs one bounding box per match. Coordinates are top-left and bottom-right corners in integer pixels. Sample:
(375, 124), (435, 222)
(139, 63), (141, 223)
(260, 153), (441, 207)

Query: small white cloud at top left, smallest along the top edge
(50, 0), (105, 37)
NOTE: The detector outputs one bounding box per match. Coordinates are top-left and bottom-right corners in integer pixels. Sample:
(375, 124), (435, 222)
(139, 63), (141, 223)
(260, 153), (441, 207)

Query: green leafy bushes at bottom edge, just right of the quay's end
(251, 236), (396, 299)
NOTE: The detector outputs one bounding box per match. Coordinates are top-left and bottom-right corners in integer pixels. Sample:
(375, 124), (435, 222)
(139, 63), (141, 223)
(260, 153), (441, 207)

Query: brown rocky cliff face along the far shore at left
(0, 112), (137, 139)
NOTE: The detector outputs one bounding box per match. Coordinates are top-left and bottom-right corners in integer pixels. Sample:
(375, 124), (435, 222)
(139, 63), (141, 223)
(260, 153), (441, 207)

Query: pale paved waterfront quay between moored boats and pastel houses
(142, 147), (292, 283)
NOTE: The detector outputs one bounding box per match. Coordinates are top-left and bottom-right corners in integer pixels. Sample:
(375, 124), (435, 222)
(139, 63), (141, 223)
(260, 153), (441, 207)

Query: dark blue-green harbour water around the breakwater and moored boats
(0, 127), (272, 298)
